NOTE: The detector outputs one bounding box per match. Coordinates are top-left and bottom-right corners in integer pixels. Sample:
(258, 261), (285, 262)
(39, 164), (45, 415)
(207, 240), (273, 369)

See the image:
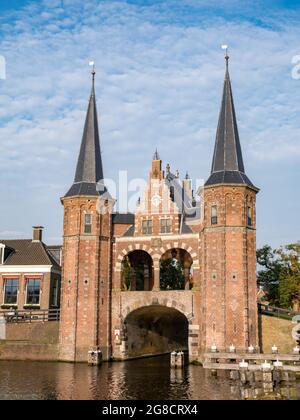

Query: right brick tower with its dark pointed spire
(202, 53), (259, 350)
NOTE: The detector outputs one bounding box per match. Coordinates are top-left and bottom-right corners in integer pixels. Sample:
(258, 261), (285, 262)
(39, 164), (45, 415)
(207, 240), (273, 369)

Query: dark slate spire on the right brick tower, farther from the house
(205, 50), (253, 186)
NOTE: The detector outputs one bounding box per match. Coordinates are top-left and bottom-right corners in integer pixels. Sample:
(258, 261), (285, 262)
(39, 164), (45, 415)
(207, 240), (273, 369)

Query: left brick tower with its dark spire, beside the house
(60, 71), (111, 361)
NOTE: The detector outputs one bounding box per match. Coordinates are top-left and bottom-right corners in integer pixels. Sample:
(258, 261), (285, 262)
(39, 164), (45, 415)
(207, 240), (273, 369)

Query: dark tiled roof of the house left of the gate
(0, 239), (60, 270)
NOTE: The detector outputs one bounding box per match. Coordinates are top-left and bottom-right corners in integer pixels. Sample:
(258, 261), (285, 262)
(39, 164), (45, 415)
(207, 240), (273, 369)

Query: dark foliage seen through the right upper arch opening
(160, 258), (184, 290)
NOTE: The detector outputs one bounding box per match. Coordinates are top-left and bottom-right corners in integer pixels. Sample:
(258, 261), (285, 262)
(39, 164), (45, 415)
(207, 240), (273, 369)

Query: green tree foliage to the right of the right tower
(257, 242), (300, 311)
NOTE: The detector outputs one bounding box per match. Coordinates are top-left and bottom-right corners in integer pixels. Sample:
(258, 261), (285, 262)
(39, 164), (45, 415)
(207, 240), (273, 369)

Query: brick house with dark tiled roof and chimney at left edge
(0, 226), (61, 311)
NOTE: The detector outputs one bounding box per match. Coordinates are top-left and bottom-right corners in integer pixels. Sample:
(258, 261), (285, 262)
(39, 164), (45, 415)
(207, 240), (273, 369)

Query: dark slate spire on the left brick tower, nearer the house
(66, 67), (103, 196)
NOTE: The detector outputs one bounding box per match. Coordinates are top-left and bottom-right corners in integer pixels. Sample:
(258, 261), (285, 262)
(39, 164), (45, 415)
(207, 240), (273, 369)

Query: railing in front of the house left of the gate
(0, 309), (60, 323)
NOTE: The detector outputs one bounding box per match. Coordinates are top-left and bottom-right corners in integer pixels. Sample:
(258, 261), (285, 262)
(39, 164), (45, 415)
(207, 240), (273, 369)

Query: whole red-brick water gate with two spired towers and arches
(60, 57), (259, 361)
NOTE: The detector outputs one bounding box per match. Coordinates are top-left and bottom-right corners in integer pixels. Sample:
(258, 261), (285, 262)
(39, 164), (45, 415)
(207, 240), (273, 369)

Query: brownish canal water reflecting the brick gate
(0, 356), (300, 400)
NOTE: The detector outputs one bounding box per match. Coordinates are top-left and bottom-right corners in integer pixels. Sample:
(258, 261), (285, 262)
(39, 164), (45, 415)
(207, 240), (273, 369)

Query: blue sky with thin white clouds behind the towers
(0, 0), (300, 247)
